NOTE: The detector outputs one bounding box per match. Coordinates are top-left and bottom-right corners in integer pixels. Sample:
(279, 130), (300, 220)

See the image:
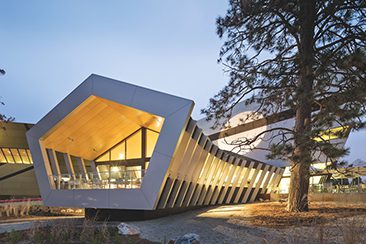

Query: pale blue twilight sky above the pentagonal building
(0, 0), (366, 160)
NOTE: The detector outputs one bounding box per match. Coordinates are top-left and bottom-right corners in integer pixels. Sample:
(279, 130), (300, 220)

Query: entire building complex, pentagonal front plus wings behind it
(0, 75), (358, 219)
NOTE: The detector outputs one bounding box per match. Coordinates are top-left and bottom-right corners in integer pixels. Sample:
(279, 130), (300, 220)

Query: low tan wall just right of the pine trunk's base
(309, 192), (366, 203)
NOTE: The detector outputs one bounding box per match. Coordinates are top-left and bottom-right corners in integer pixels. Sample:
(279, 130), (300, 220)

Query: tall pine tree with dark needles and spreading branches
(202, 0), (366, 212)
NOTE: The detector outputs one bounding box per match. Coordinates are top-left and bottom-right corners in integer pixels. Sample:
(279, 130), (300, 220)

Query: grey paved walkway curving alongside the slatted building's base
(129, 205), (276, 244)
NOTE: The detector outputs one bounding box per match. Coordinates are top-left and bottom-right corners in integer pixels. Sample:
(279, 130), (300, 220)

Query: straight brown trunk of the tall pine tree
(287, 0), (316, 212)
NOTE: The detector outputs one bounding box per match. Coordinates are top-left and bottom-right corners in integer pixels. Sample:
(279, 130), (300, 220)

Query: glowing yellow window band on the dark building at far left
(0, 148), (33, 164)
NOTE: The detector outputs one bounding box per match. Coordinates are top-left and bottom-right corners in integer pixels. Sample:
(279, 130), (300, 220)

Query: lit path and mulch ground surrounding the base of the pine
(131, 202), (366, 244)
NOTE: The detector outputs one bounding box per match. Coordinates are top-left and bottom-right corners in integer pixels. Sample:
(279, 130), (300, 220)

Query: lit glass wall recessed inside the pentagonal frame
(50, 128), (159, 189)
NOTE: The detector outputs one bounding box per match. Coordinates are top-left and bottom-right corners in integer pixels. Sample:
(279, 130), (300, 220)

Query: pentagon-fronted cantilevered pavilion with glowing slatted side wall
(27, 75), (284, 217)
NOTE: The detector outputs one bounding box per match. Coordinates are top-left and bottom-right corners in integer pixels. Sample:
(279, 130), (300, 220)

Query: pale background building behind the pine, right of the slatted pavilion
(198, 101), (366, 194)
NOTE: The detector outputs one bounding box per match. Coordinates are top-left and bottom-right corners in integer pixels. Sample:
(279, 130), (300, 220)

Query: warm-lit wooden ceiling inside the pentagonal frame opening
(41, 96), (164, 160)
